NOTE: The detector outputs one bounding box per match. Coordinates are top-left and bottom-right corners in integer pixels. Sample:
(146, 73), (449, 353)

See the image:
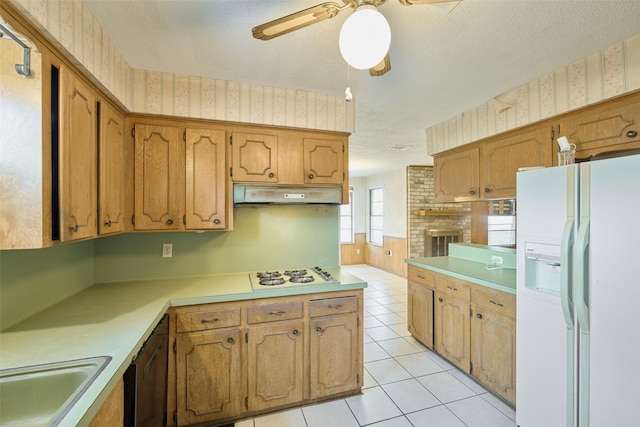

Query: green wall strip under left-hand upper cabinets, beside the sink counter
(0, 241), (94, 330)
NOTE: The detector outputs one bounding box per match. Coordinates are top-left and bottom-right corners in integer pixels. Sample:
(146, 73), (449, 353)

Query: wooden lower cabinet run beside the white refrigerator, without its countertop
(407, 266), (516, 404)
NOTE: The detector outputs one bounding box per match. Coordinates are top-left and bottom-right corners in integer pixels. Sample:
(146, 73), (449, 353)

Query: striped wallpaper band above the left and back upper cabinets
(9, 0), (355, 132)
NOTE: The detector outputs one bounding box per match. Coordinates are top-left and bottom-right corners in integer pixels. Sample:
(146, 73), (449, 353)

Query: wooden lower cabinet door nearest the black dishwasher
(176, 329), (245, 426)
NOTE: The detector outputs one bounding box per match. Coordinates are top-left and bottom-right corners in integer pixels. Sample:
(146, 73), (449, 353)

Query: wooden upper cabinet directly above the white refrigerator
(555, 93), (640, 160)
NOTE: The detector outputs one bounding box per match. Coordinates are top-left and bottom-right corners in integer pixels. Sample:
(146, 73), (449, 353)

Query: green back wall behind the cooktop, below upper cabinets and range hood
(95, 205), (339, 283)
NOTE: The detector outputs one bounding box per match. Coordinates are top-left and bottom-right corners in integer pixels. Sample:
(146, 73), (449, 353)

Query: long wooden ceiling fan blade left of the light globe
(251, 1), (348, 40)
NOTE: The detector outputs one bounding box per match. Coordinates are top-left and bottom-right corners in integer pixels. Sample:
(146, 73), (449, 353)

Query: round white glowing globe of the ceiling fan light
(339, 5), (391, 70)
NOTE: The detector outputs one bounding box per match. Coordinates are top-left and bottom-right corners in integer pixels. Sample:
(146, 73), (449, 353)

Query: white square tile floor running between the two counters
(235, 265), (516, 427)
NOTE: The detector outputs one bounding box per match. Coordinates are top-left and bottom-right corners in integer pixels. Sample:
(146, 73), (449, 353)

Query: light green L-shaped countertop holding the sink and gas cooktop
(0, 268), (367, 426)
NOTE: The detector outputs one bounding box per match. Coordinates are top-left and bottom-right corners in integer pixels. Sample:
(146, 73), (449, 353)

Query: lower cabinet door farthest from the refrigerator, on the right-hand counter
(407, 282), (433, 350)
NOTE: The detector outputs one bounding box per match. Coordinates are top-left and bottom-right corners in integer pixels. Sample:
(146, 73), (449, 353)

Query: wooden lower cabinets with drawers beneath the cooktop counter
(168, 290), (363, 426)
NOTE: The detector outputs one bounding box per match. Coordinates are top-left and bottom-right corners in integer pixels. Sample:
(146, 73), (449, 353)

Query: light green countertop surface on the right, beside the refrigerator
(406, 256), (516, 294)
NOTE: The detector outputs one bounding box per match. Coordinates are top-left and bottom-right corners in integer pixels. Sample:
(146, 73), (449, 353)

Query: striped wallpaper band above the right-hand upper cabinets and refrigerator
(426, 34), (640, 155)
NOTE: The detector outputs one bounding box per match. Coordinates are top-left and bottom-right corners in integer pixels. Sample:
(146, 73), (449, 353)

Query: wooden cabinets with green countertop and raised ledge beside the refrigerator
(406, 243), (516, 405)
